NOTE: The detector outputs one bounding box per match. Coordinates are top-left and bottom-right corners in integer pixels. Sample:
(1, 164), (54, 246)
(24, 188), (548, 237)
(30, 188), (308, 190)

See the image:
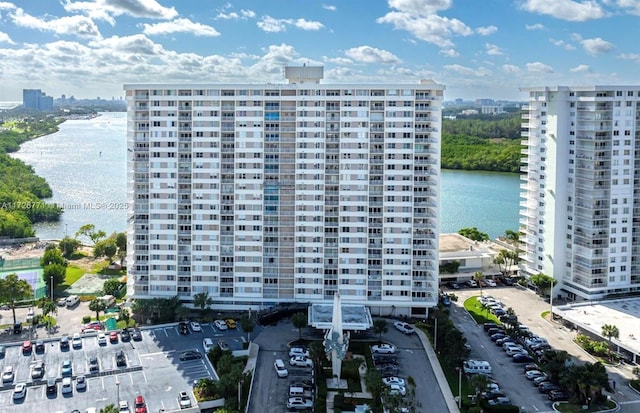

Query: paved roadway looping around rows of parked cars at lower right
(451, 287), (640, 413)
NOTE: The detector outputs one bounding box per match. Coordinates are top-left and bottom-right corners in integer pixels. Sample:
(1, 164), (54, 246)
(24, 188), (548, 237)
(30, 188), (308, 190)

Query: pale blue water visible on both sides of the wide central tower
(14, 112), (520, 239)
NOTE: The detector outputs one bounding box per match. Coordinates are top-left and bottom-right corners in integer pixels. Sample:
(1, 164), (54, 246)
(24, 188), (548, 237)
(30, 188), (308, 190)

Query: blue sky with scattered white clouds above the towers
(0, 0), (640, 101)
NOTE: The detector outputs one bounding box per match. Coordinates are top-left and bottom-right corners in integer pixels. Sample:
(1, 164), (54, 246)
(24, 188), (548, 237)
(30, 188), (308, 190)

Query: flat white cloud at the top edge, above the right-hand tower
(522, 0), (606, 22)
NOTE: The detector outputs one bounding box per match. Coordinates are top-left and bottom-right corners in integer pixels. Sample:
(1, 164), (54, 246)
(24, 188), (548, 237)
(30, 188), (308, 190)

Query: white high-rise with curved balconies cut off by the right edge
(520, 86), (640, 300)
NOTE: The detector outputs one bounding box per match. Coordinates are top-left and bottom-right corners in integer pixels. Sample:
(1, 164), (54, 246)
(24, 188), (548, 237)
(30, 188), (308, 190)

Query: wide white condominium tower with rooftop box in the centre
(125, 66), (444, 314)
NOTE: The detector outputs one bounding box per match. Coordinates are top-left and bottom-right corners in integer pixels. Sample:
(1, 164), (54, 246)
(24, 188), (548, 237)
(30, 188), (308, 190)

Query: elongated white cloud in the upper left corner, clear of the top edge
(9, 8), (100, 38)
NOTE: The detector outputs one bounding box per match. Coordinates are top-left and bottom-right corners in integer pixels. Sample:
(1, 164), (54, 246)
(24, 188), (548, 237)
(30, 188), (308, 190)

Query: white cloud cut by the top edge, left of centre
(63, 0), (178, 20)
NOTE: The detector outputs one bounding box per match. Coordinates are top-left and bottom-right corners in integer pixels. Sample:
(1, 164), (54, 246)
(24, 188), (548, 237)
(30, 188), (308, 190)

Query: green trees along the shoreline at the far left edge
(0, 118), (62, 238)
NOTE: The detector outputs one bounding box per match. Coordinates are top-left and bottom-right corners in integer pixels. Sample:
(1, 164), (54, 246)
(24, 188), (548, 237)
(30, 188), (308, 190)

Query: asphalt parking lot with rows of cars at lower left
(0, 324), (244, 412)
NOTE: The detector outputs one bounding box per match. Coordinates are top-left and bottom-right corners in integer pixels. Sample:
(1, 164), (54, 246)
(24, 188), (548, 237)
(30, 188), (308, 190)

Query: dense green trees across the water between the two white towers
(441, 112), (522, 173)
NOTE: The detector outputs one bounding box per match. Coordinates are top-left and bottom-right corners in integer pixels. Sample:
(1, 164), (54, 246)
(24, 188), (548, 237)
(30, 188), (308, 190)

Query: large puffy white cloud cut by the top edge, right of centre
(376, 0), (473, 48)
